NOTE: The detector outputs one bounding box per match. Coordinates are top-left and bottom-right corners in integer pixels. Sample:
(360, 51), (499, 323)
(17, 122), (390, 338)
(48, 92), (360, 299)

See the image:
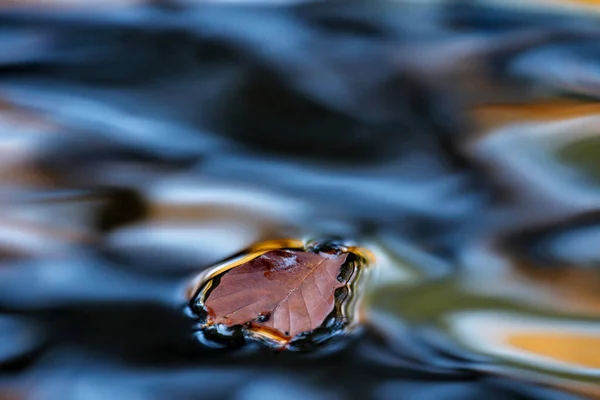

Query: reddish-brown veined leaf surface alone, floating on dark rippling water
(205, 250), (347, 339)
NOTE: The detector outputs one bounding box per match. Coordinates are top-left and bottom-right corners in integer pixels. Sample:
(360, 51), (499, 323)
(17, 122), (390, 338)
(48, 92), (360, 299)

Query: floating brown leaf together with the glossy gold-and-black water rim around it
(190, 244), (366, 345)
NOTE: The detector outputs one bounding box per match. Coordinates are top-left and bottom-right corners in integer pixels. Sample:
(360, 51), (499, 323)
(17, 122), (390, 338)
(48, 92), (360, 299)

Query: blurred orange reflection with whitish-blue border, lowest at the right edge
(448, 311), (600, 380)
